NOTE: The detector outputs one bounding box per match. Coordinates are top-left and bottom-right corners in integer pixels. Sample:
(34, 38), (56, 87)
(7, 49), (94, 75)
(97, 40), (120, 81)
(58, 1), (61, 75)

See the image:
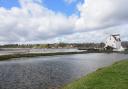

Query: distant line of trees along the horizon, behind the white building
(0, 41), (128, 48)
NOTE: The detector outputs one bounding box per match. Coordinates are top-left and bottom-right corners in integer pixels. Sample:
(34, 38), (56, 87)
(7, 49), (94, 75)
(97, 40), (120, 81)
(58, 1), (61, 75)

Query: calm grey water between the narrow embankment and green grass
(0, 53), (128, 89)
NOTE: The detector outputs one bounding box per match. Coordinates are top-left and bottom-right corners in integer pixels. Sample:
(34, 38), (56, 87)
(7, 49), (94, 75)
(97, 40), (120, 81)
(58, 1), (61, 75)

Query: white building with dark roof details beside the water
(105, 34), (124, 51)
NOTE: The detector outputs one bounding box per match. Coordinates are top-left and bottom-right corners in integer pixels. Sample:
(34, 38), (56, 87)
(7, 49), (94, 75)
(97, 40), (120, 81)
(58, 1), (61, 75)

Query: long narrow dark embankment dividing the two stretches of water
(0, 50), (127, 61)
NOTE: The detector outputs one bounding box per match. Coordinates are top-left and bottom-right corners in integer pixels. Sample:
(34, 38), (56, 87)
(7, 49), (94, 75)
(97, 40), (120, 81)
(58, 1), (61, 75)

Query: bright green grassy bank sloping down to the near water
(62, 60), (128, 89)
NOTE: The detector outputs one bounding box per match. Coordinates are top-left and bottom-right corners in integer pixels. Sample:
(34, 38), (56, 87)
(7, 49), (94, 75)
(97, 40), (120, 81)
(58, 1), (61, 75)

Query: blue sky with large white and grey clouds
(0, 0), (128, 44)
